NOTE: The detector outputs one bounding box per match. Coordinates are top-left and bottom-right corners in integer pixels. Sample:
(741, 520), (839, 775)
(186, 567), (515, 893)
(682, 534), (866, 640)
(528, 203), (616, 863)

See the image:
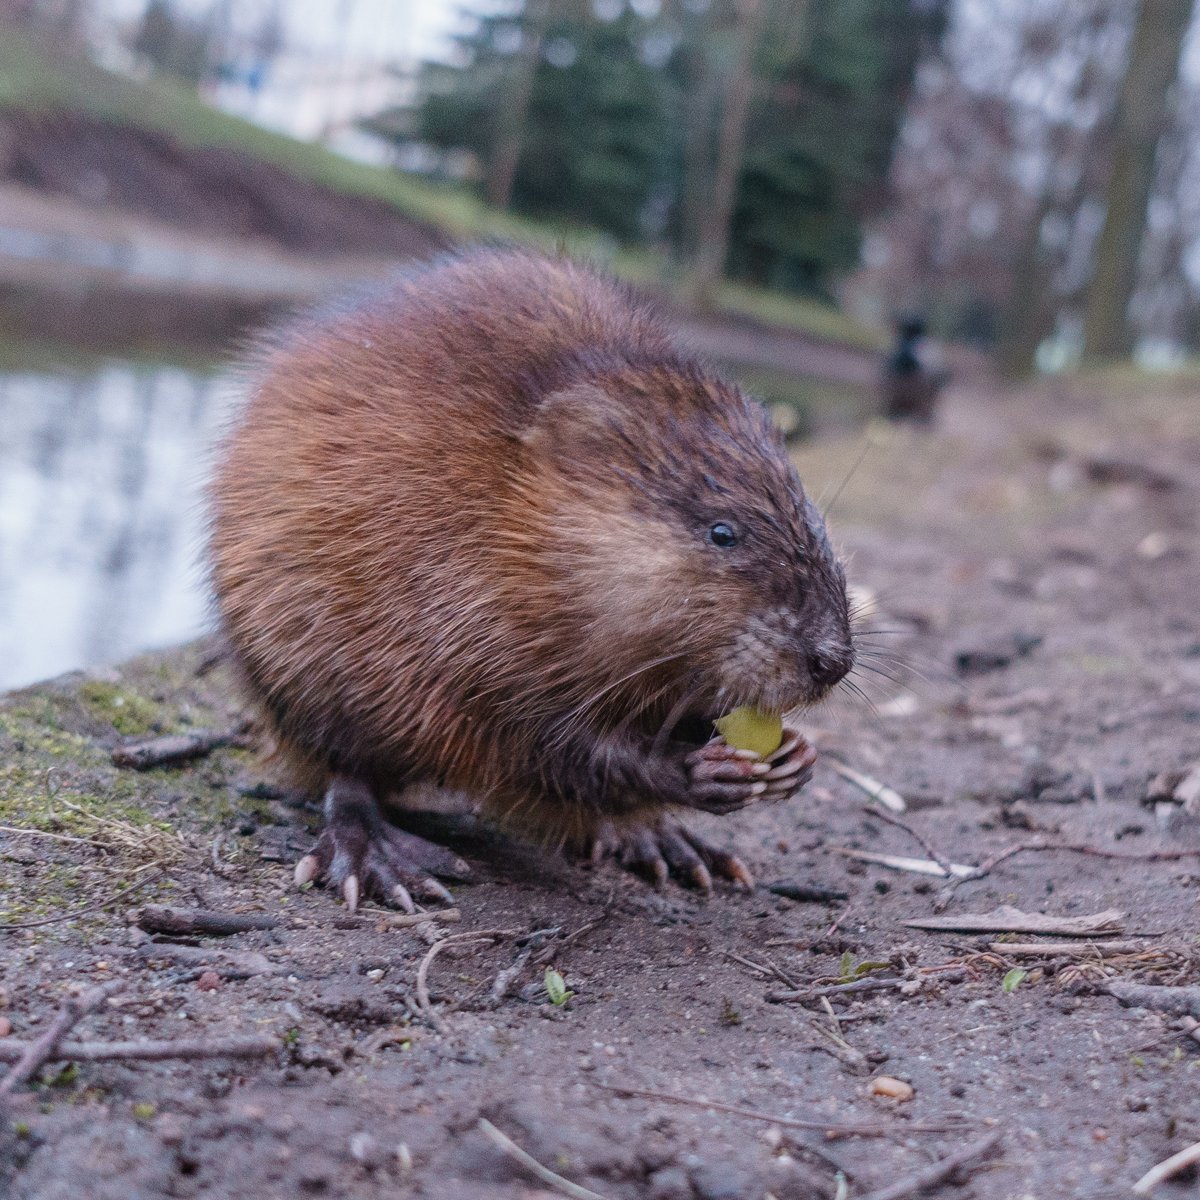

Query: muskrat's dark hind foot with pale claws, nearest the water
(295, 775), (470, 912)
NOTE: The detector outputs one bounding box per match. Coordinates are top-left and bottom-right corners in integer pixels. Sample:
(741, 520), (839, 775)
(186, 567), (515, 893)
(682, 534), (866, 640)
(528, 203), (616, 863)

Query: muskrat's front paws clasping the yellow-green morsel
(684, 728), (817, 812)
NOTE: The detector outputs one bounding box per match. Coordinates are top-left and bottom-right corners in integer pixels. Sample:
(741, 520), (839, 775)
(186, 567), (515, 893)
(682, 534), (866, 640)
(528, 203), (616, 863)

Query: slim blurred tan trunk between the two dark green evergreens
(689, 0), (767, 311)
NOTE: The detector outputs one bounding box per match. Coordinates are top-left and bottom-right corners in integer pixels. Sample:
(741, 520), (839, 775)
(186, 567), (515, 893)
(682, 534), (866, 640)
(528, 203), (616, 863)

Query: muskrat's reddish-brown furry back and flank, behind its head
(212, 251), (670, 784)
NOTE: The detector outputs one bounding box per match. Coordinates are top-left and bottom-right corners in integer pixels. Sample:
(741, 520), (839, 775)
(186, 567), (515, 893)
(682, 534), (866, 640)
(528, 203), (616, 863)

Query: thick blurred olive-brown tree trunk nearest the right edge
(1084, 0), (1192, 360)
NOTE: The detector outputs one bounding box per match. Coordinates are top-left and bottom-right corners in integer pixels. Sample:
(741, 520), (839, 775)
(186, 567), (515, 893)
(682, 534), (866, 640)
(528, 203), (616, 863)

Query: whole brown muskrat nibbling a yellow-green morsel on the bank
(211, 250), (854, 908)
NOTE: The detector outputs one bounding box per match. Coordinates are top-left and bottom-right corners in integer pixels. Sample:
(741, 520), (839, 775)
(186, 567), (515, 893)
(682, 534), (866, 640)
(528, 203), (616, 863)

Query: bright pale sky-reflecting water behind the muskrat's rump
(0, 361), (235, 690)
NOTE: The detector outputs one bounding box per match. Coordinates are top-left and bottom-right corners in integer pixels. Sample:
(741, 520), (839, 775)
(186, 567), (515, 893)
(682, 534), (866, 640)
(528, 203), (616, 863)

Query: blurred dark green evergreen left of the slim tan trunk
(412, 0), (676, 240)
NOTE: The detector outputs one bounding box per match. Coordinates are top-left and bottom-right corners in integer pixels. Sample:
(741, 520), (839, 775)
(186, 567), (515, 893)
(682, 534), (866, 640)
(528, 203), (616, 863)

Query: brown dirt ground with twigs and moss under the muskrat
(0, 376), (1200, 1200)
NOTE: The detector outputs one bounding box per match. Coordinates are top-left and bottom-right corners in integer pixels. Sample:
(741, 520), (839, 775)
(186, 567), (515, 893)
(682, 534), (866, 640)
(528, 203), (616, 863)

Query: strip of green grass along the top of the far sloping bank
(0, 26), (884, 350)
